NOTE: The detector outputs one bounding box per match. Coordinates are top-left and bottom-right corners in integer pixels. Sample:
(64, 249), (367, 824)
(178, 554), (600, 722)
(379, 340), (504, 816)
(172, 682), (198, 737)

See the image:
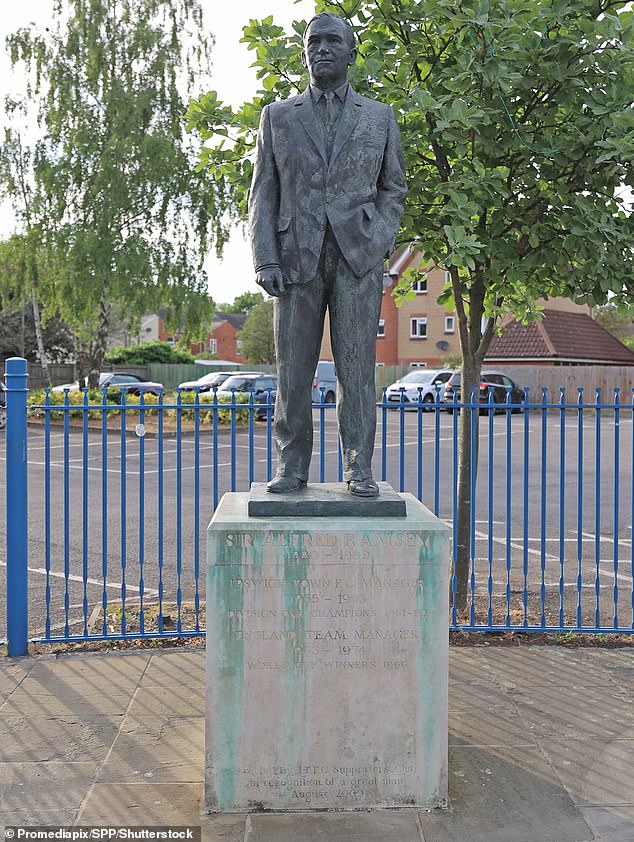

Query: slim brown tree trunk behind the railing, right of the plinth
(454, 357), (481, 613)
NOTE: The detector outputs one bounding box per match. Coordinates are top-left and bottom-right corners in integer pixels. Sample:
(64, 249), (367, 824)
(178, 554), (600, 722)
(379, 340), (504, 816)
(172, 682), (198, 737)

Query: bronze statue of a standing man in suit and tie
(249, 12), (407, 497)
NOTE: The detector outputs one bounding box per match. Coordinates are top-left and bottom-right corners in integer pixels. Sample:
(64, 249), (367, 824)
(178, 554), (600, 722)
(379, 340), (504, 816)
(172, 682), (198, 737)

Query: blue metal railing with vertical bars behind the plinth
(6, 360), (634, 654)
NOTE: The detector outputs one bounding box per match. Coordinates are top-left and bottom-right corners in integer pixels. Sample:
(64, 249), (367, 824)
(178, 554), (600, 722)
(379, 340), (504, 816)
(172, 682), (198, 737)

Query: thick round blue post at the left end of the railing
(4, 357), (29, 656)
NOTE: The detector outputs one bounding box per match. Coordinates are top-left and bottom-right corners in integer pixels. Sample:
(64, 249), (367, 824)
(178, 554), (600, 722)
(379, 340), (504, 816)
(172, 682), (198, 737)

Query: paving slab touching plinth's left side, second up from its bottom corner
(99, 716), (205, 783)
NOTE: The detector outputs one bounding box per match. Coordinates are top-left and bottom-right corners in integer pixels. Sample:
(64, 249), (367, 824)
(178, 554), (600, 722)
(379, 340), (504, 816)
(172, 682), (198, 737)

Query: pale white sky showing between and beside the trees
(0, 0), (315, 303)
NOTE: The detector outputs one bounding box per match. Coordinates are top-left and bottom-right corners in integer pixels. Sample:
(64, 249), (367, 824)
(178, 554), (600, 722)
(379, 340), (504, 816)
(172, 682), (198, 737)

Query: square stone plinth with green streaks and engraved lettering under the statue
(205, 494), (449, 812)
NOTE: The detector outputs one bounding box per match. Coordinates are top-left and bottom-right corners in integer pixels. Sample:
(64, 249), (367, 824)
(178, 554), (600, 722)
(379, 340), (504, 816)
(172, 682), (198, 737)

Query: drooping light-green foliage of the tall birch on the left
(3, 0), (230, 385)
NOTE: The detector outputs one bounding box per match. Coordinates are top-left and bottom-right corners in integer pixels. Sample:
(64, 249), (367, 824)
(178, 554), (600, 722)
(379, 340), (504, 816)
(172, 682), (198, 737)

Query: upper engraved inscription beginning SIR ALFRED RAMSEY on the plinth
(220, 531), (426, 672)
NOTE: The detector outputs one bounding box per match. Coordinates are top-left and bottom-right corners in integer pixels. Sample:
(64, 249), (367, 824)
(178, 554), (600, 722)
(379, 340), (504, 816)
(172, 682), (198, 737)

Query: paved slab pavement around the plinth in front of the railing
(0, 645), (634, 842)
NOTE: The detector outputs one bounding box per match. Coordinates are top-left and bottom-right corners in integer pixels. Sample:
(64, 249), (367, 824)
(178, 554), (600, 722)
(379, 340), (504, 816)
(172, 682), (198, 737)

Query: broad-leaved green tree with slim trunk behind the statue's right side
(188, 0), (634, 610)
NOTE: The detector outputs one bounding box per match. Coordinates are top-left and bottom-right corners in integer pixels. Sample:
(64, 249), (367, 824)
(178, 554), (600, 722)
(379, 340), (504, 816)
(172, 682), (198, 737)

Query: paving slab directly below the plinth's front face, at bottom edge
(245, 811), (422, 842)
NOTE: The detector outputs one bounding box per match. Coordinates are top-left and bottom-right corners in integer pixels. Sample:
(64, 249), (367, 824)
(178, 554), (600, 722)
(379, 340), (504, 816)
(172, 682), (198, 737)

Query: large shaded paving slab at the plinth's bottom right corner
(420, 746), (594, 842)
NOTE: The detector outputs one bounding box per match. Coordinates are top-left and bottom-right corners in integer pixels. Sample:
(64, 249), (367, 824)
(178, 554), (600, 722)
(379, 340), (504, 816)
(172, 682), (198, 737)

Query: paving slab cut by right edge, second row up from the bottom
(540, 730), (634, 804)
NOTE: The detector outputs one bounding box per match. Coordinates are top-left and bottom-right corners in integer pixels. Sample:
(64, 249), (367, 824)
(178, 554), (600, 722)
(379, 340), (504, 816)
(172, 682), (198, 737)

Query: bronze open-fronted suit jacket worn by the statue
(249, 87), (407, 284)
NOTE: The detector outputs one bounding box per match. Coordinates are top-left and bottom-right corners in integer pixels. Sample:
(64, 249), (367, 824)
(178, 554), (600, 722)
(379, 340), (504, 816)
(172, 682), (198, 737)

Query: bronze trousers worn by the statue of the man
(273, 226), (383, 481)
